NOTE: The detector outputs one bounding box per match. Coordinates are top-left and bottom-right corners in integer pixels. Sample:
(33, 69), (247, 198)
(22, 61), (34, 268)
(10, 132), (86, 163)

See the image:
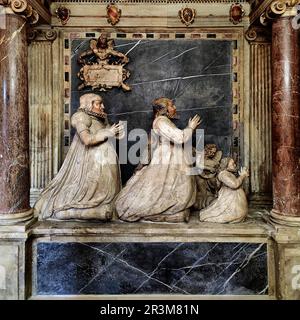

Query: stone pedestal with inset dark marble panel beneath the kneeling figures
(29, 215), (275, 299)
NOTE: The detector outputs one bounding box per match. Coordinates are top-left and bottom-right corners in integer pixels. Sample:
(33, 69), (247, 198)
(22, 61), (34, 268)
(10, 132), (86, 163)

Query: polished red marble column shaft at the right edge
(271, 17), (300, 225)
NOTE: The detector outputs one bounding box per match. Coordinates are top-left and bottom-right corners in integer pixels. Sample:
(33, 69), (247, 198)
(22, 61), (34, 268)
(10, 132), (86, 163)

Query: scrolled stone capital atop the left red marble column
(0, 0), (39, 24)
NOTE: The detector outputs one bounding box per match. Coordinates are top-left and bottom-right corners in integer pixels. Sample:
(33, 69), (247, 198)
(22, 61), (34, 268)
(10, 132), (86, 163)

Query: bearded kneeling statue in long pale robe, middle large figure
(116, 98), (200, 222)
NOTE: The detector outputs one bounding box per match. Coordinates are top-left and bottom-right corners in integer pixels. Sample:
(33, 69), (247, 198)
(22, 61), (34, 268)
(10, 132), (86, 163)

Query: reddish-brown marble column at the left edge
(0, 13), (32, 224)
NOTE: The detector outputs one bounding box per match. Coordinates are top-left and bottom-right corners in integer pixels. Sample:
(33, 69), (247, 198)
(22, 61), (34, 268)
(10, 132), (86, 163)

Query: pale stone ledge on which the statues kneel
(32, 212), (274, 242)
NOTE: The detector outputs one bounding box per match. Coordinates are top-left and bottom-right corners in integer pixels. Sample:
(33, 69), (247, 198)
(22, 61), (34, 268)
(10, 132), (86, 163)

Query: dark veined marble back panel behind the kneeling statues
(71, 39), (234, 183)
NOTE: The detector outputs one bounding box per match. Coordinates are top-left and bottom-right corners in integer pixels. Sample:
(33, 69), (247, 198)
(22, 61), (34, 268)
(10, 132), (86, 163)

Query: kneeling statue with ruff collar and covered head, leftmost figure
(34, 94), (124, 221)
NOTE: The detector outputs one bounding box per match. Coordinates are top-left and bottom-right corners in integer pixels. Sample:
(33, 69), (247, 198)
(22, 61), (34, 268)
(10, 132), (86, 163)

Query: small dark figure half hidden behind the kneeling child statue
(194, 144), (223, 210)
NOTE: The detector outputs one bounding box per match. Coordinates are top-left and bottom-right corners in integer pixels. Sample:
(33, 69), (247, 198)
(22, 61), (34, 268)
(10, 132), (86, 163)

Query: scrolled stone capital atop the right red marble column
(260, 0), (300, 26)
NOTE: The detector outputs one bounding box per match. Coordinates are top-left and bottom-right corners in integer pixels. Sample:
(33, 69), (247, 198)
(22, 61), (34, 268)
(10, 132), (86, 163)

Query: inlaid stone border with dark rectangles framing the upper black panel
(62, 28), (247, 174)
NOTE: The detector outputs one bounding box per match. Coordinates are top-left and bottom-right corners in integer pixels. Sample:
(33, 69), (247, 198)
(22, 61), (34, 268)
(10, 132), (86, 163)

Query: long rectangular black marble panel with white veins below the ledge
(34, 242), (268, 295)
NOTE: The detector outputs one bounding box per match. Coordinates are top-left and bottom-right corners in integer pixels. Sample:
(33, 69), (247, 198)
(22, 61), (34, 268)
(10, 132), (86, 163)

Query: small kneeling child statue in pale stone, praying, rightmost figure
(200, 158), (249, 223)
